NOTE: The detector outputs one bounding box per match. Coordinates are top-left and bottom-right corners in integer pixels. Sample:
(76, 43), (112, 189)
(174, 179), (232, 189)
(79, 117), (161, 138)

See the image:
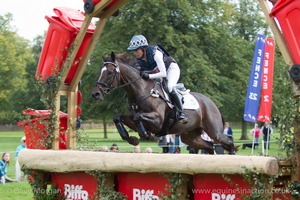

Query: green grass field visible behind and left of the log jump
(0, 128), (283, 200)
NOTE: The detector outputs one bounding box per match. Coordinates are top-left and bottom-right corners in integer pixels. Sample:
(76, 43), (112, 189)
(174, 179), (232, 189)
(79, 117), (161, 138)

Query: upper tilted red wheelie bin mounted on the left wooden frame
(35, 7), (96, 84)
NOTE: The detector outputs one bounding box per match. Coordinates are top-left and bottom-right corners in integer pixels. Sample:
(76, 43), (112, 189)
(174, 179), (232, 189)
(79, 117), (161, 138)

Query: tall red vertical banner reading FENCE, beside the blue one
(257, 38), (275, 122)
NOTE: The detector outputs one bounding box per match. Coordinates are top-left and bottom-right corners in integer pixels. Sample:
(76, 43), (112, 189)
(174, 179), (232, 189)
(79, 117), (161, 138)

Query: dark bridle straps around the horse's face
(96, 62), (120, 94)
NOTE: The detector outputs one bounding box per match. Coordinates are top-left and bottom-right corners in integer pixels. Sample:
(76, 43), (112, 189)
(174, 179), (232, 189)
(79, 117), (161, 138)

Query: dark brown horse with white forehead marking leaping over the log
(92, 52), (235, 154)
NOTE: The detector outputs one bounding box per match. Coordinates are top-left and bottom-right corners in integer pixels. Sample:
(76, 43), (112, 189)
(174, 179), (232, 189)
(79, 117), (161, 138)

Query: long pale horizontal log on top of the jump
(19, 149), (279, 176)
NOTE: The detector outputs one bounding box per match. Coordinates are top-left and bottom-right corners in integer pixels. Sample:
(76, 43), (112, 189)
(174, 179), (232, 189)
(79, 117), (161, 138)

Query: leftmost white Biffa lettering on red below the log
(64, 184), (89, 200)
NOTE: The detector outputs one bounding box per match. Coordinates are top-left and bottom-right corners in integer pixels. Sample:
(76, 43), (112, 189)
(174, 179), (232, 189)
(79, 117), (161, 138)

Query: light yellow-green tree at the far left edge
(0, 13), (32, 123)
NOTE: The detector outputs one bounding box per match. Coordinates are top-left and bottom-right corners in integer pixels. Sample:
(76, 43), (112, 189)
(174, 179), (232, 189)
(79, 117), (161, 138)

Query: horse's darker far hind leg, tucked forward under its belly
(180, 128), (214, 154)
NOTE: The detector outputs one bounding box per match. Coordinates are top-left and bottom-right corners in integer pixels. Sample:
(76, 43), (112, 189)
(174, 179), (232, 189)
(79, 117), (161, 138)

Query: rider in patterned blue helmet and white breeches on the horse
(127, 35), (188, 123)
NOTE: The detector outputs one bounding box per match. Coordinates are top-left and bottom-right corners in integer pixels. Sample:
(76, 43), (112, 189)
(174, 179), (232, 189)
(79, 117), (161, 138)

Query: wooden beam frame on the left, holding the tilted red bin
(52, 0), (128, 149)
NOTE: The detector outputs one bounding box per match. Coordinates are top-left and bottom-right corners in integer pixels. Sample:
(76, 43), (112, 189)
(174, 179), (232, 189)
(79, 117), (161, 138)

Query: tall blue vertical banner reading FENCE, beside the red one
(244, 34), (266, 122)
